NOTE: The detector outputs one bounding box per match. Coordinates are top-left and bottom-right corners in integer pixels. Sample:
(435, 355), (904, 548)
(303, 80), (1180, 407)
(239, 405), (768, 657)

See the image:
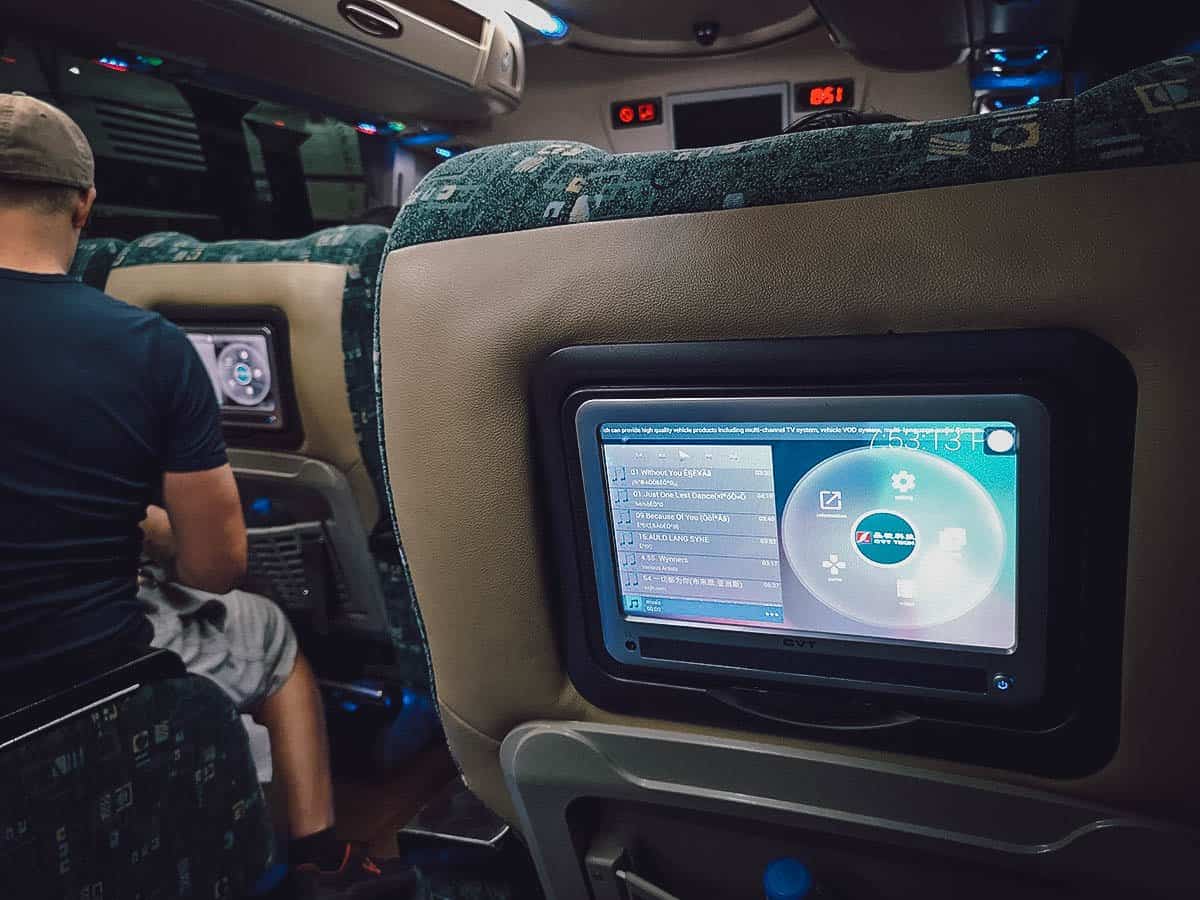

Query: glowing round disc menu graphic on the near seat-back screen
(780, 446), (1006, 629)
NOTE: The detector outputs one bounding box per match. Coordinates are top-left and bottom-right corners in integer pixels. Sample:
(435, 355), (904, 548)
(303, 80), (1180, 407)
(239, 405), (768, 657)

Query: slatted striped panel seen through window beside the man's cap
(95, 100), (205, 172)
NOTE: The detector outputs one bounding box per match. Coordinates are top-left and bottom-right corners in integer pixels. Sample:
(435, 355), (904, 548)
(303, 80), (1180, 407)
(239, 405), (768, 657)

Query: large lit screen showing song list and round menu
(599, 418), (1021, 653)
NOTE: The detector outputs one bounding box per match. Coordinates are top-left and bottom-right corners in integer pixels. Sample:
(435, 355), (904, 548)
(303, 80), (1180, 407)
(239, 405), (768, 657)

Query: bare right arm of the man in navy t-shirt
(160, 463), (246, 594)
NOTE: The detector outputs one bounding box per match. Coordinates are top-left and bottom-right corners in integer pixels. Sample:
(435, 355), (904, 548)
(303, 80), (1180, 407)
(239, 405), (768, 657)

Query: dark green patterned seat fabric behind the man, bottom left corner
(0, 676), (275, 900)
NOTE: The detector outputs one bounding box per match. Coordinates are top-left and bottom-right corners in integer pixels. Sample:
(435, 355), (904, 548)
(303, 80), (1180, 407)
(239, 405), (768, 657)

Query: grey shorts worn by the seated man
(138, 571), (298, 712)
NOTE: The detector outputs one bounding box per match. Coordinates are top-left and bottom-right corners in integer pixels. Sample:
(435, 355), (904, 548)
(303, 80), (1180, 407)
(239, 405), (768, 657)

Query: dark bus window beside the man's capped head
(0, 35), (428, 240)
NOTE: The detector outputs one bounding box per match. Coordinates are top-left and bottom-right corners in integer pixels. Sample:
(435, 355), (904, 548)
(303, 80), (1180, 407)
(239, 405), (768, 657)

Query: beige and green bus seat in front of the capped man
(107, 226), (428, 684)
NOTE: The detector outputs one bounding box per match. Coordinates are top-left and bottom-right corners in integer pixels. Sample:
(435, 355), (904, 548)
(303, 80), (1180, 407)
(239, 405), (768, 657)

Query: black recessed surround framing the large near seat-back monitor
(532, 330), (1136, 775)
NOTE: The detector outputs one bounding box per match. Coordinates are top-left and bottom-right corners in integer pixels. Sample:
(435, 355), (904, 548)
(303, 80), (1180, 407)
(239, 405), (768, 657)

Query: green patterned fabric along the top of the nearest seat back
(388, 56), (1200, 252)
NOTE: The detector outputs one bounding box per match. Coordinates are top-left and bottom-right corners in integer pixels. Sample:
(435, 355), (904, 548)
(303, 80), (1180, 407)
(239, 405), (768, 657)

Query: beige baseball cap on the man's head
(0, 94), (96, 191)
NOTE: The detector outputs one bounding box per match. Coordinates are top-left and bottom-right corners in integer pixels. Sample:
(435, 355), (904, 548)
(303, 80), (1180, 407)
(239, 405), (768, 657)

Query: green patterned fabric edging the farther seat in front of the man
(114, 226), (430, 686)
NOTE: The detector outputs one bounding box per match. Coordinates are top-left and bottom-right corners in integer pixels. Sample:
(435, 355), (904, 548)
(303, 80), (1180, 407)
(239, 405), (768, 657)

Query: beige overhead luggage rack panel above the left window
(5, 0), (524, 121)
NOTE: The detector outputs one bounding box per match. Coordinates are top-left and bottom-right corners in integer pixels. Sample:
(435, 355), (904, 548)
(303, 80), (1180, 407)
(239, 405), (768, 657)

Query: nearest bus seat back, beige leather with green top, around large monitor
(378, 55), (1200, 821)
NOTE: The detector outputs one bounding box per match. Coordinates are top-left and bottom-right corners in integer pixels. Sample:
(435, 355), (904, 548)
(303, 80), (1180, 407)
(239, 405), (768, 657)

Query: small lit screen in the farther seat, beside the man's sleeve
(185, 328), (278, 427)
